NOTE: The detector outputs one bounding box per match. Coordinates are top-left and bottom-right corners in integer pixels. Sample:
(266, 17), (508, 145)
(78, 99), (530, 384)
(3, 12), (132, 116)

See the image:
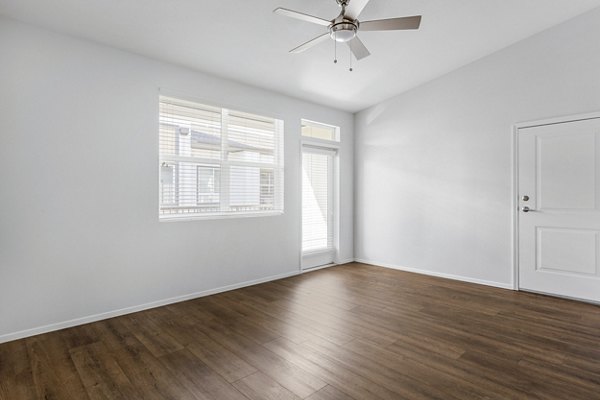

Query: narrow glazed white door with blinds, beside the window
(302, 146), (336, 269)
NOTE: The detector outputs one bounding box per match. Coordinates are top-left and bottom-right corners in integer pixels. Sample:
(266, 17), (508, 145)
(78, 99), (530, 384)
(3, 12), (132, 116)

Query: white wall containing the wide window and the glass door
(0, 18), (354, 342)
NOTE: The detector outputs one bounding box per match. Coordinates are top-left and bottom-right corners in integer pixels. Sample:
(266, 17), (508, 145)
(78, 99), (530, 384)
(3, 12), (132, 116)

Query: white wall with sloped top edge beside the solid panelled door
(355, 6), (600, 286)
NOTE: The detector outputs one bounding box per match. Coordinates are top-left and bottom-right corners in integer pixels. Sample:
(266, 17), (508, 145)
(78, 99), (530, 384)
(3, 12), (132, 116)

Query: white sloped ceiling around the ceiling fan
(0, 0), (600, 112)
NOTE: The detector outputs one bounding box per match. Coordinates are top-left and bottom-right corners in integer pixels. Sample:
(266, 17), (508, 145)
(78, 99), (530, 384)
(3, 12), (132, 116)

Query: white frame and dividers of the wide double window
(158, 93), (285, 222)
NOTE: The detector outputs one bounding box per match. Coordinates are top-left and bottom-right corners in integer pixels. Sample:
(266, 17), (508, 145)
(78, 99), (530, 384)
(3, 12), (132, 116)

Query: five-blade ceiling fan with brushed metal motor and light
(273, 0), (421, 60)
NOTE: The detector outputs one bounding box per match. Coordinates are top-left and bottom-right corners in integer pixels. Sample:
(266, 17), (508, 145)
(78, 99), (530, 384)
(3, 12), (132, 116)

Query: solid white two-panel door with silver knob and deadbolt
(518, 119), (600, 302)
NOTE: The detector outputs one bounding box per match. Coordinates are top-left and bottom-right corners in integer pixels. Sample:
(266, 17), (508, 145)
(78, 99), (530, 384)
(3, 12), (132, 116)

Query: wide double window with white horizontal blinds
(159, 96), (283, 219)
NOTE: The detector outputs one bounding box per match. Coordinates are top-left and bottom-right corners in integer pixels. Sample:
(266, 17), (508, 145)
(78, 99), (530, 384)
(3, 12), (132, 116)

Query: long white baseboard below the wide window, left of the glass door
(0, 271), (300, 343)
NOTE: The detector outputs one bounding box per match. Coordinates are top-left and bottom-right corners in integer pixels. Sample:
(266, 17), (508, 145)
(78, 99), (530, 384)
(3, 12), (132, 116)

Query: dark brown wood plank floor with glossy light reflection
(0, 264), (600, 400)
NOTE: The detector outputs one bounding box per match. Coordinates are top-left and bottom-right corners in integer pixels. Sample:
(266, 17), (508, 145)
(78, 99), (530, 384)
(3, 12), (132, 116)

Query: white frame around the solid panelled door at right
(510, 111), (600, 291)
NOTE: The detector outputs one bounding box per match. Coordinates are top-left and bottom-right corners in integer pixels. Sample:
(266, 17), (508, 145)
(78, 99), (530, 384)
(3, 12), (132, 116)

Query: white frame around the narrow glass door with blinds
(299, 137), (341, 273)
